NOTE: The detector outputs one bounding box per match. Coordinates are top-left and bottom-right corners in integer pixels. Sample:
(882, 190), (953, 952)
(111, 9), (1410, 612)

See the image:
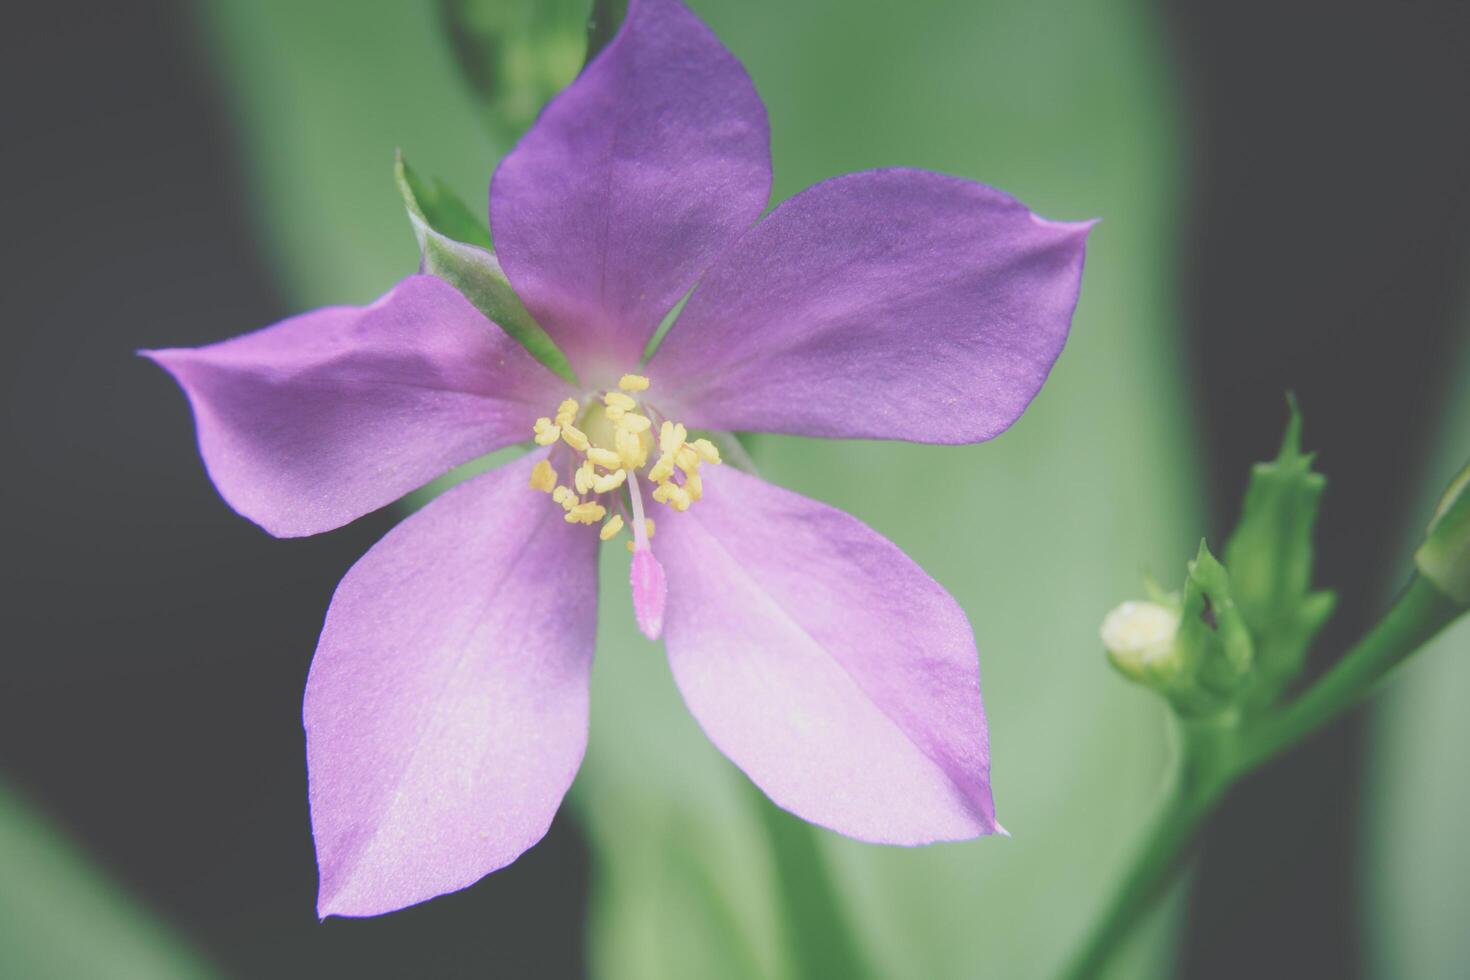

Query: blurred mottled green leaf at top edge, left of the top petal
(438, 0), (628, 145)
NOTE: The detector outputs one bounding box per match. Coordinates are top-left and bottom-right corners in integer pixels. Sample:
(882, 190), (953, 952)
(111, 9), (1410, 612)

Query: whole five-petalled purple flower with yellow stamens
(148, 0), (1088, 915)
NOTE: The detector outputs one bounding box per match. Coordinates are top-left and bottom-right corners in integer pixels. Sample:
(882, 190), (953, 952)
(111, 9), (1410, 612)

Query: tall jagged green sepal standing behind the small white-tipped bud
(1225, 395), (1336, 708)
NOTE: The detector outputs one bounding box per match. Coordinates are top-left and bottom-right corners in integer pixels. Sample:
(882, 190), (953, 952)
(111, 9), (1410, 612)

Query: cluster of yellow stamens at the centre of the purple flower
(531, 375), (720, 551)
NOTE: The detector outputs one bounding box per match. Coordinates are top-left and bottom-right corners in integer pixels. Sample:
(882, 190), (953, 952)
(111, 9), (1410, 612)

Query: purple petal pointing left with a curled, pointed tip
(143, 276), (566, 538)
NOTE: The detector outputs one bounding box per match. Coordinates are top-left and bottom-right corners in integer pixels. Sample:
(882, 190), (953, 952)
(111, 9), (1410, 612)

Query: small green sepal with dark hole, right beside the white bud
(1170, 541), (1255, 707)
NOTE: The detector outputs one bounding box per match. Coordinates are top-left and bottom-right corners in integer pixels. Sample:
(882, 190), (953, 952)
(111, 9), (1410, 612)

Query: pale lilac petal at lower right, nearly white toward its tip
(656, 467), (998, 845)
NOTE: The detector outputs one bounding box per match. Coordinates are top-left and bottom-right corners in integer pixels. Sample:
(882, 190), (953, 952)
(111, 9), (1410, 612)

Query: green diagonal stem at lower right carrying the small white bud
(1061, 574), (1466, 980)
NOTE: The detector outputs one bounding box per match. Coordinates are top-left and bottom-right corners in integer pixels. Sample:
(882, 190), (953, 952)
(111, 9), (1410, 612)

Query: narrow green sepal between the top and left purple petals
(394, 151), (576, 383)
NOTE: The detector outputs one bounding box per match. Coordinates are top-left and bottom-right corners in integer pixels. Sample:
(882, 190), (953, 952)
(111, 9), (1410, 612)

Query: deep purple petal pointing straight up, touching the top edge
(490, 0), (770, 385)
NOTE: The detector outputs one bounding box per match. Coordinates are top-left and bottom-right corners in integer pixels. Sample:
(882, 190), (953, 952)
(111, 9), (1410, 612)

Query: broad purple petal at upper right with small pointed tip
(647, 170), (1091, 444)
